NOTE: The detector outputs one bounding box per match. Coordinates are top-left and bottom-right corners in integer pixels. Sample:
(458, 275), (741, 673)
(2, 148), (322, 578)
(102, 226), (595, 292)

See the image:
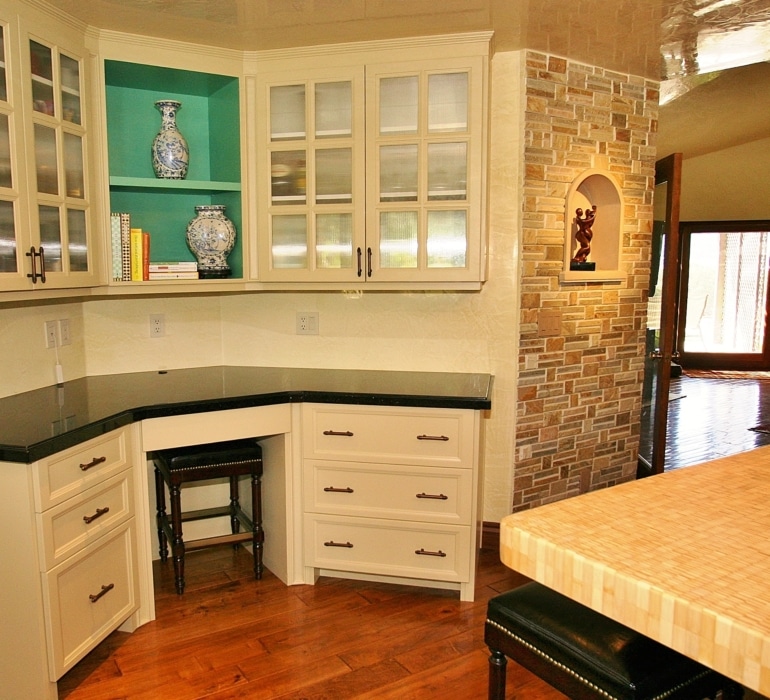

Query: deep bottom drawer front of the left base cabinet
(43, 518), (138, 681)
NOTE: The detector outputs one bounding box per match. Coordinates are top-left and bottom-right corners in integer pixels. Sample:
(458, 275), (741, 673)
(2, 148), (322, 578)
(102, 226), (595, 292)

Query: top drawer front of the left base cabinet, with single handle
(33, 427), (129, 513)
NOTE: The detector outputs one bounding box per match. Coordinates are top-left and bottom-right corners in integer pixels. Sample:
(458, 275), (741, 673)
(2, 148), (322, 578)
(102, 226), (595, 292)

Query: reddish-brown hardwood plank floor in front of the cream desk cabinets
(59, 547), (564, 700)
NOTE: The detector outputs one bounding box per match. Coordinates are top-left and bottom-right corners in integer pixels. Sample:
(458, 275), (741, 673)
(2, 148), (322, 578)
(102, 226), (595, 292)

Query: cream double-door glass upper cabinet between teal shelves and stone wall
(252, 34), (489, 288)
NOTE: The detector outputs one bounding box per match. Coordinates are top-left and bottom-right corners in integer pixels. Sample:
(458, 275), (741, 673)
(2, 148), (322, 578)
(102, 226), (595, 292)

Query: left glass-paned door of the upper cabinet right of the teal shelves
(258, 70), (365, 281)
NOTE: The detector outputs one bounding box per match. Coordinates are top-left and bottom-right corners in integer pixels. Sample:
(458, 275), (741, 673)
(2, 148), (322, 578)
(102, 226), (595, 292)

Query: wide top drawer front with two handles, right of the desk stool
(302, 404), (476, 468)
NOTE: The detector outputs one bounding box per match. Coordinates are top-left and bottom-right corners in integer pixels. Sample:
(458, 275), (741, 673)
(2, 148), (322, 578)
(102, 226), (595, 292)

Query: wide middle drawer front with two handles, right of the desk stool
(303, 460), (473, 525)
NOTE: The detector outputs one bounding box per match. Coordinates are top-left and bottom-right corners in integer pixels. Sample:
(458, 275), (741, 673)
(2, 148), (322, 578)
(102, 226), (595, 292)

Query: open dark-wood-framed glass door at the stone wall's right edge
(637, 153), (682, 477)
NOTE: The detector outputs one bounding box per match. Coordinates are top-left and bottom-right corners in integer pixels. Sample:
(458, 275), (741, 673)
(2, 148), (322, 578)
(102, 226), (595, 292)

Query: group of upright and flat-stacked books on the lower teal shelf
(110, 212), (198, 282)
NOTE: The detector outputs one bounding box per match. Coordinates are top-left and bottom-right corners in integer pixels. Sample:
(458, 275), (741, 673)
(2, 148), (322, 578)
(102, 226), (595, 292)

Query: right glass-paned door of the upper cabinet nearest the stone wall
(366, 59), (484, 282)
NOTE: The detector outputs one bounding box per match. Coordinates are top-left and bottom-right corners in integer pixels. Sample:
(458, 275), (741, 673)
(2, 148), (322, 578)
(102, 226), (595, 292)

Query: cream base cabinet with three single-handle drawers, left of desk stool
(0, 427), (139, 698)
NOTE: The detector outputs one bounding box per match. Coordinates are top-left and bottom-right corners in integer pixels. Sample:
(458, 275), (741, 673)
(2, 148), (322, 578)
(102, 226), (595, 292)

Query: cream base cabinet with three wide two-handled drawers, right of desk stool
(302, 404), (480, 600)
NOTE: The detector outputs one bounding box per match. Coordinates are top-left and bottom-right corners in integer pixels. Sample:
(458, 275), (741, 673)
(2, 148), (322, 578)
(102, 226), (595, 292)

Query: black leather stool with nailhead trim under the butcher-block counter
(484, 582), (743, 700)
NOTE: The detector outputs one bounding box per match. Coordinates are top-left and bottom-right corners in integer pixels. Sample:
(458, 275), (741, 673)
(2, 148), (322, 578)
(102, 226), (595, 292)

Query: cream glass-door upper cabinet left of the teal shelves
(0, 2), (98, 291)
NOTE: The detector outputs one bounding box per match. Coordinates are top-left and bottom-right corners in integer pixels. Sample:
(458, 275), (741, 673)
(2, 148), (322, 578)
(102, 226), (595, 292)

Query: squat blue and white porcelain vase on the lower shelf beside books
(187, 204), (235, 279)
